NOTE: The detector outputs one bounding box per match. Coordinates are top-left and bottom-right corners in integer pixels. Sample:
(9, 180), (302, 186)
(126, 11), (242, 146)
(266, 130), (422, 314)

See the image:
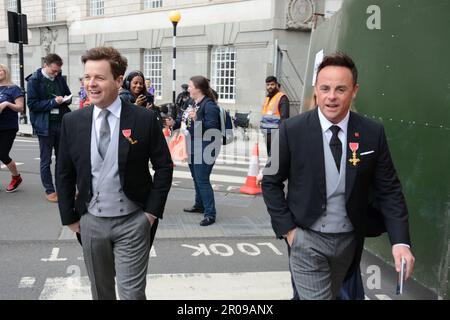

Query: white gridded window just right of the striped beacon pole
(211, 47), (236, 103)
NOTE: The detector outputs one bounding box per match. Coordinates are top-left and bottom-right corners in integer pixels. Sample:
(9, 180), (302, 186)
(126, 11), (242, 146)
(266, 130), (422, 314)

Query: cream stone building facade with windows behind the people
(0, 0), (342, 122)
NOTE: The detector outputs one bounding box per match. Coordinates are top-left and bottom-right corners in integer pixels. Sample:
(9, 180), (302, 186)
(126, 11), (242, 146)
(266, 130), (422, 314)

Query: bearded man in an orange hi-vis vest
(260, 76), (289, 156)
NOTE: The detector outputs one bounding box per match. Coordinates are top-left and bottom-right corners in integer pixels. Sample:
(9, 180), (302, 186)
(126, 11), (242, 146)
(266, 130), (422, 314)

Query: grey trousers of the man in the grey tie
(80, 210), (151, 300)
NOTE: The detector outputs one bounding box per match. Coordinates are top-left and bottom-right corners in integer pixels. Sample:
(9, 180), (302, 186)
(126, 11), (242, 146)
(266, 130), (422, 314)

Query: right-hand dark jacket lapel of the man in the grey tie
(118, 101), (137, 186)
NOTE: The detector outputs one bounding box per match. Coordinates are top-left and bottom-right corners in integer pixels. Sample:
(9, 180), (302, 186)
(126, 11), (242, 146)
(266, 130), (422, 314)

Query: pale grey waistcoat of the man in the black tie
(310, 134), (353, 233)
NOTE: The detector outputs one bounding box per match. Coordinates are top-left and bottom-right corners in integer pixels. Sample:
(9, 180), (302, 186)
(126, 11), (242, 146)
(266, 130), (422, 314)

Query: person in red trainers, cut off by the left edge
(0, 64), (24, 192)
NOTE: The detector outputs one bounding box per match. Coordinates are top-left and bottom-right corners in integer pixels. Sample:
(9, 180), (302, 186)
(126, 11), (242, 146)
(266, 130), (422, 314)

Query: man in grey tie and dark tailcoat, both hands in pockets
(57, 47), (173, 300)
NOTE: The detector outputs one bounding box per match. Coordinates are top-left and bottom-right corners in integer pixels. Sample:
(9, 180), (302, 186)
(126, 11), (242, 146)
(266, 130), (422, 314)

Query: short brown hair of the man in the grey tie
(81, 47), (128, 79)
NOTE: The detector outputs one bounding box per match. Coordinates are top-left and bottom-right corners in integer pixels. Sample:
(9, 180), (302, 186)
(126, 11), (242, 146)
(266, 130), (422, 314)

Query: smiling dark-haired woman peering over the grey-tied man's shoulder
(119, 71), (154, 109)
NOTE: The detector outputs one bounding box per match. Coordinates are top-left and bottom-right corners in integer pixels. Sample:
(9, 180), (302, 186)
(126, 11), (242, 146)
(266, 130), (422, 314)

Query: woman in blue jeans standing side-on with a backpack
(166, 76), (222, 226)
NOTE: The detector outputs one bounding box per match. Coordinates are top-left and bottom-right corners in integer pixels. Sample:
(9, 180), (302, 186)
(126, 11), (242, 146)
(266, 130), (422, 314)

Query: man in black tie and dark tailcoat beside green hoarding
(262, 54), (414, 300)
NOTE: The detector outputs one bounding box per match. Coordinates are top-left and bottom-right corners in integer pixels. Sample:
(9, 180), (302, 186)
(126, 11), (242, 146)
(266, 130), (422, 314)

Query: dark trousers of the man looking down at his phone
(38, 123), (61, 194)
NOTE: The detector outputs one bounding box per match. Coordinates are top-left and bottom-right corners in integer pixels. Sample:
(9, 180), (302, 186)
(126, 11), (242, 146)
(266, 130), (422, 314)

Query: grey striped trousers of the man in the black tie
(289, 228), (356, 300)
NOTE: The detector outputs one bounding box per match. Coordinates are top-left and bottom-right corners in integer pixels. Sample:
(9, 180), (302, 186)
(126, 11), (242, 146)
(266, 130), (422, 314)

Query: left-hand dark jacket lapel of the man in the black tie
(308, 108), (327, 199)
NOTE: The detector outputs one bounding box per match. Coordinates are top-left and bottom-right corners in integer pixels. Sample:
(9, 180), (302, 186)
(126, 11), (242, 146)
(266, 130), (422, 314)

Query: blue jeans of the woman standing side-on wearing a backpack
(189, 163), (216, 218)
